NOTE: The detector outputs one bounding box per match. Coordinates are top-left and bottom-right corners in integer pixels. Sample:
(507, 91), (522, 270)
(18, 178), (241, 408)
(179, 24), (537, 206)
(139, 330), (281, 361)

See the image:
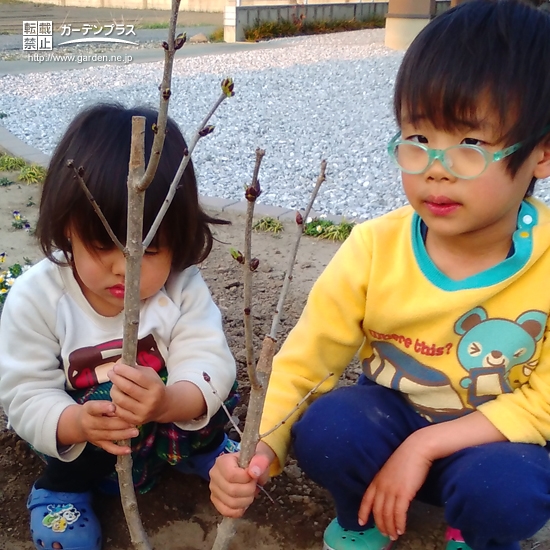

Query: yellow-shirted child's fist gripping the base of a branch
(210, 441), (275, 518)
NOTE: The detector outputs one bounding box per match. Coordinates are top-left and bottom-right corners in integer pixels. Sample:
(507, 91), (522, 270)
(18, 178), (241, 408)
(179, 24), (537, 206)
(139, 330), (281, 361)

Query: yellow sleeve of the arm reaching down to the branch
(260, 224), (371, 475)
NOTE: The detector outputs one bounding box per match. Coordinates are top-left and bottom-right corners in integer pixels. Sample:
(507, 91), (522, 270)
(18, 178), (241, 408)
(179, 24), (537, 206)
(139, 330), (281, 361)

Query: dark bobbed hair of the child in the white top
(36, 104), (228, 270)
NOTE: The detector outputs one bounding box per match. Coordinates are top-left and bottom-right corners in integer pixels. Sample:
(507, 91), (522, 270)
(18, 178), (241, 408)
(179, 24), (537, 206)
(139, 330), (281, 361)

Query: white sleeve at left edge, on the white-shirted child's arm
(0, 271), (85, 462)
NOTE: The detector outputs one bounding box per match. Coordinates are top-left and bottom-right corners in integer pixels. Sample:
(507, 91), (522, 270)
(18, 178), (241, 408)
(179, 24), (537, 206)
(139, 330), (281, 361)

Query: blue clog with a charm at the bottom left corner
(27, 487), (101, 550)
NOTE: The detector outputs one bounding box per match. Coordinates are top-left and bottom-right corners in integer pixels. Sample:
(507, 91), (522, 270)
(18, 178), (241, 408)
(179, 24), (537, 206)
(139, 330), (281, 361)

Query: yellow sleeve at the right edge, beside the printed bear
(478, 321), (550, 446)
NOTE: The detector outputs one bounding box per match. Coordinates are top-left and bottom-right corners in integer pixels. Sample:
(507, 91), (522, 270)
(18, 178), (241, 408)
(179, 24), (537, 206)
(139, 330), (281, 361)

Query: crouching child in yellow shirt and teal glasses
(210, 0), (550, 550)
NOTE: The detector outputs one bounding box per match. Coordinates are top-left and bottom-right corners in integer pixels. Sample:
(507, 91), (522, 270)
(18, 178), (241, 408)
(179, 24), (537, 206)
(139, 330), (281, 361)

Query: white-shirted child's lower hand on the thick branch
(75, 401), (139, 455)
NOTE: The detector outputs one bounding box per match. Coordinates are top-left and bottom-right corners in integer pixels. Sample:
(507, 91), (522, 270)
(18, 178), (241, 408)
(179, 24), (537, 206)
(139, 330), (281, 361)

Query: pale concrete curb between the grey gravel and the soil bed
(0, 124), (354, 223)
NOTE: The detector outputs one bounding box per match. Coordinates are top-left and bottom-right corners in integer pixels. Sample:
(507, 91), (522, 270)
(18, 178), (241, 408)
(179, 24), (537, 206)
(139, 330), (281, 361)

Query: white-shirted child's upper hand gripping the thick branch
(108, 363), (166, 426)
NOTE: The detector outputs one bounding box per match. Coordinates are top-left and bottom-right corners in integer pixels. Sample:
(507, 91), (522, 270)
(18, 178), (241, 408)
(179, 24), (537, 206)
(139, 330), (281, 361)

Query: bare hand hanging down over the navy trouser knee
(359, 439), (432, 540)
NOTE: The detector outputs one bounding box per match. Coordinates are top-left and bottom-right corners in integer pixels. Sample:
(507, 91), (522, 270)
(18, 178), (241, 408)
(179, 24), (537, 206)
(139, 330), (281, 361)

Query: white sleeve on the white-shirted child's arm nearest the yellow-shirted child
(167, 266), (236, 430)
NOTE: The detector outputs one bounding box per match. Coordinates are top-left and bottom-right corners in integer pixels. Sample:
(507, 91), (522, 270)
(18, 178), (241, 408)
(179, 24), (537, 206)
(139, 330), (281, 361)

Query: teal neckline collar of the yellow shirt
(411, 201), (538, 292)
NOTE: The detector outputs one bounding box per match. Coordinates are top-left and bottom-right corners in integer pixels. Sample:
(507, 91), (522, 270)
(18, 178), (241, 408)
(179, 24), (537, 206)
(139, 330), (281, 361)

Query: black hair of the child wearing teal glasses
(394, 0), (550, 195)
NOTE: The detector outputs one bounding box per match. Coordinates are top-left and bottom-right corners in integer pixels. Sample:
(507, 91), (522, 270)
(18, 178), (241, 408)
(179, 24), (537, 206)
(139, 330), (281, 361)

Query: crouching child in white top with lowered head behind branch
(0, 105), (236, 550)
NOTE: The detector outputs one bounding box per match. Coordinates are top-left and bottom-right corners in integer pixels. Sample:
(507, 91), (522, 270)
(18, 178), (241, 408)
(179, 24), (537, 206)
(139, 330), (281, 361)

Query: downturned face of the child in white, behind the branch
(69, 231), (172, 317)
